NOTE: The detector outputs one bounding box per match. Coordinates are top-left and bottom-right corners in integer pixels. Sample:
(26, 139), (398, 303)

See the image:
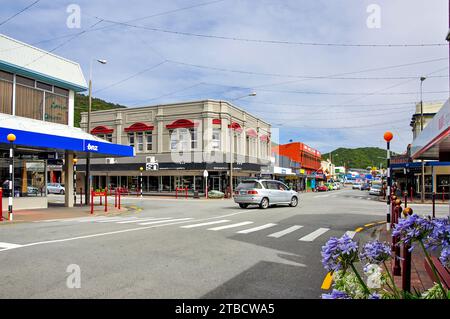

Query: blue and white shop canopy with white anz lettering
(0, 114), (134, 157)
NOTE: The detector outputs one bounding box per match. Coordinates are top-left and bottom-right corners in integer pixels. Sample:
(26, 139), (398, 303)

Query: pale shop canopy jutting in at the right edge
(411, 100), (450, 160)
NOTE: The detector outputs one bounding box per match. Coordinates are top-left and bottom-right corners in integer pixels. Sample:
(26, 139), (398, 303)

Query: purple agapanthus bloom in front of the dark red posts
(392, 214), (433, 244)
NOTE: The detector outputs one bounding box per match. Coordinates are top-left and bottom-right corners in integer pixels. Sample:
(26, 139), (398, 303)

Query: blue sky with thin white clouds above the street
(0, 0), (449, 153)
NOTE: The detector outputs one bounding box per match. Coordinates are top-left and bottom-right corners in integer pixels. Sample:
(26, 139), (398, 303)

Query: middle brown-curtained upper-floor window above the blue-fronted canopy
(15, 85), (43, 120)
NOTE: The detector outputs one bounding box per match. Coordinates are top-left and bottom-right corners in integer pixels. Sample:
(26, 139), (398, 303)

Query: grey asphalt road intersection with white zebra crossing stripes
(0, 189), (448, 298)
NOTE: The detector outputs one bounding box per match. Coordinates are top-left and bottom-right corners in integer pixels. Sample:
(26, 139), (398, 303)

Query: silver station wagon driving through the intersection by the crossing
(234, 179), (298, 209)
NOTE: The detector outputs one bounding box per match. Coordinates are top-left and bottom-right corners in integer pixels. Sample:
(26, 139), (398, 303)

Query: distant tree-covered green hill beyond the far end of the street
(322, 147), (394, 168)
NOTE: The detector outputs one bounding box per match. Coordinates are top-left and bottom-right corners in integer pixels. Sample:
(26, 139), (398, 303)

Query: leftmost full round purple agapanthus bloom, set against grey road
(322, 234), (358, 271)
